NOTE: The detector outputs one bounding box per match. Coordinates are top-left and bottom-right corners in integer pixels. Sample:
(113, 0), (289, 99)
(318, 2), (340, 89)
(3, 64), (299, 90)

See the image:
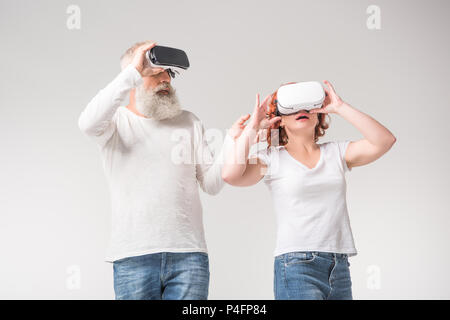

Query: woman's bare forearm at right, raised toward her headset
(337, 102), (396, 148)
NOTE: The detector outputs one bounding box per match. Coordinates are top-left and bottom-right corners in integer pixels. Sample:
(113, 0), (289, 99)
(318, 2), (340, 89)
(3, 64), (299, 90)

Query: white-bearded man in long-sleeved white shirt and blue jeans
(78, 41), (232, 299)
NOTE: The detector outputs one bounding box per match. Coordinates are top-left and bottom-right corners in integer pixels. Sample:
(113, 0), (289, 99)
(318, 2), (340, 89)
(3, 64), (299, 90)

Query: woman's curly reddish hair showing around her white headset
(267, 86), (329, 147)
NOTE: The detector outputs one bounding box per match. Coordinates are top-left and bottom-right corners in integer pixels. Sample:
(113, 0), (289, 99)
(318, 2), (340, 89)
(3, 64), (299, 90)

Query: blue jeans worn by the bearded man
(113, 252), (209, 300)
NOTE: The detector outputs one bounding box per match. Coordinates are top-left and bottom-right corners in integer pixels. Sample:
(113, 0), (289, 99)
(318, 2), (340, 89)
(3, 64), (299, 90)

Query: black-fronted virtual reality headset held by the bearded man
(145, 46), (189, 78)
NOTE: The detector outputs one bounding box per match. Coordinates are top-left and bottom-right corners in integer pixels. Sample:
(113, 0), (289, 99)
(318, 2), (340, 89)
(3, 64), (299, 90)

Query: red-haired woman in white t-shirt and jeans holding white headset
(222, 81), (396, 299)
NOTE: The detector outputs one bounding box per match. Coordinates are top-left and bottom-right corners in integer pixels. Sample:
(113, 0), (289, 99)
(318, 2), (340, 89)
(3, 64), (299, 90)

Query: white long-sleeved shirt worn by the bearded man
(78, 65), (232, 262)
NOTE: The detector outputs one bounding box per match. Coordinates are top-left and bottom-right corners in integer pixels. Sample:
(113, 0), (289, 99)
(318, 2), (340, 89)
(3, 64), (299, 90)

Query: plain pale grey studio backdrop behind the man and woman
(0, 0), (450, 299)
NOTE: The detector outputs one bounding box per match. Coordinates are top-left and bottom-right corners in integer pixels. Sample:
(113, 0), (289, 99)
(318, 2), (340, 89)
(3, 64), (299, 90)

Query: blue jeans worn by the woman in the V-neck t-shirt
(274, 251), (353, 300)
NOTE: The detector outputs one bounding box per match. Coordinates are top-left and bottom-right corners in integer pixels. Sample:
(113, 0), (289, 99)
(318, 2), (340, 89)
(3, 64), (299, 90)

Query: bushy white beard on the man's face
(135, 84), (181, 120)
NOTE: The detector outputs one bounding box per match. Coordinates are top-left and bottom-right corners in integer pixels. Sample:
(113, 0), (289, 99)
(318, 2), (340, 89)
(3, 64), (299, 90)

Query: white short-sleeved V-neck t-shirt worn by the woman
(257, 140), (357, 256)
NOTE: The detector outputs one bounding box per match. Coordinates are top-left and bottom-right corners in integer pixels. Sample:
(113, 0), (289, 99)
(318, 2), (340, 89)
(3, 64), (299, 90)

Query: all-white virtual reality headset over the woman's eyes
(276, 81), (325, 115)
